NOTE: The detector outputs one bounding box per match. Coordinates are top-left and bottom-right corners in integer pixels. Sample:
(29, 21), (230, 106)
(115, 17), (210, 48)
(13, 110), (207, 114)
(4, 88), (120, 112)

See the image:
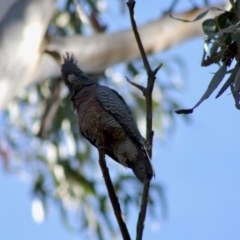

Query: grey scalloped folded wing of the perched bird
(97, 85), (144, 148)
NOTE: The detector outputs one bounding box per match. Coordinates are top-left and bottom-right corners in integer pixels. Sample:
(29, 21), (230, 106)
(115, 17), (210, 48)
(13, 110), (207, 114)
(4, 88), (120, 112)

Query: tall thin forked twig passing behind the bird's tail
(127, 0), (162, 240)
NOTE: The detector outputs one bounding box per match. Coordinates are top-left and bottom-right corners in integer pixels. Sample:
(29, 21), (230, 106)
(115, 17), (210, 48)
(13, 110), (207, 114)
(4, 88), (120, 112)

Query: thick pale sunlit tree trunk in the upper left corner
(0, 0), (56, 109)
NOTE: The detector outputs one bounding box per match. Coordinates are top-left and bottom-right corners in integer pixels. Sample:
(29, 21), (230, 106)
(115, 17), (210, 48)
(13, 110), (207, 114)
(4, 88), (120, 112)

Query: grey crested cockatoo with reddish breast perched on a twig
(61, 53), (154, 183)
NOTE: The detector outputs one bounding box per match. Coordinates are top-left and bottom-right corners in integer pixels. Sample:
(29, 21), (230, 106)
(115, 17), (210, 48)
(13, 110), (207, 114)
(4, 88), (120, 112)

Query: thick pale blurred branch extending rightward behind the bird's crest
(44, 6), (223, 73)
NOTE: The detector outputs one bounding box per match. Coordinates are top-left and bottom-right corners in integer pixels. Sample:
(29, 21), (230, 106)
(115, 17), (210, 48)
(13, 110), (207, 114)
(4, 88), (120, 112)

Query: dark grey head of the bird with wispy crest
(61, 53), (95, 95)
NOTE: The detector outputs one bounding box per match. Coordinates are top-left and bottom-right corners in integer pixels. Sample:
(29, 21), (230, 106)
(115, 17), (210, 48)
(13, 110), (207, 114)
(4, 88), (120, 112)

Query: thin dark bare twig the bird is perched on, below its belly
(98, 128), (131, 240)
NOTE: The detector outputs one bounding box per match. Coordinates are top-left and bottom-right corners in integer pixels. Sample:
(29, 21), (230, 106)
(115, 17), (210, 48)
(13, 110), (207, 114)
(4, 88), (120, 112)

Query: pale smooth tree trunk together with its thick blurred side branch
(0, 0), (228, 110)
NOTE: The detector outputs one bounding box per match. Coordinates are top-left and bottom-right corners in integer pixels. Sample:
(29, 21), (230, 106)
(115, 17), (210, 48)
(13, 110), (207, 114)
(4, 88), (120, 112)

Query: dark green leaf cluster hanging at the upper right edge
(173, 0), (240, 114)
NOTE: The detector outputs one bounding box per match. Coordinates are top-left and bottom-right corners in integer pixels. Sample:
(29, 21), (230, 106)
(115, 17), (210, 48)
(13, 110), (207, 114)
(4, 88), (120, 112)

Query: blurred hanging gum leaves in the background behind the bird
(0, 0), (231, 239)
